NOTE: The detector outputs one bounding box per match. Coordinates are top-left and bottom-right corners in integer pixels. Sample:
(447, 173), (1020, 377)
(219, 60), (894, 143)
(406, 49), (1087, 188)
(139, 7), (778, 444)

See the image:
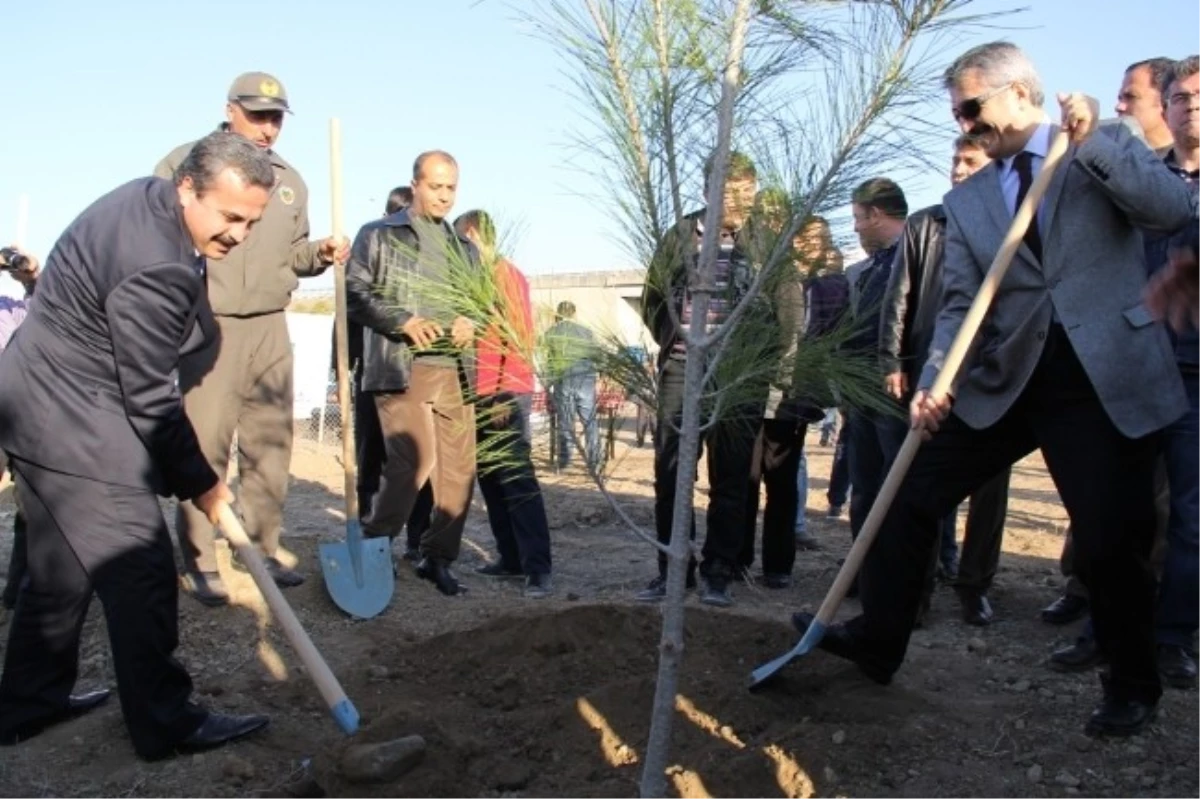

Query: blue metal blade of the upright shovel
(319, 521), (396, 619)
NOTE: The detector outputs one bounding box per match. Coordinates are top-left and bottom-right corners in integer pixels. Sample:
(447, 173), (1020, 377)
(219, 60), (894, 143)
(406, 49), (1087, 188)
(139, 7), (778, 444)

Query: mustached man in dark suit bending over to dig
(0, 133), (275, 759)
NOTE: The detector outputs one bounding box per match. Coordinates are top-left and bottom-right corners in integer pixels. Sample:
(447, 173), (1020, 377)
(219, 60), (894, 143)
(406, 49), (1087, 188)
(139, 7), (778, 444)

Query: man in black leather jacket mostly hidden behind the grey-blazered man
(880, 136), (1010, 626)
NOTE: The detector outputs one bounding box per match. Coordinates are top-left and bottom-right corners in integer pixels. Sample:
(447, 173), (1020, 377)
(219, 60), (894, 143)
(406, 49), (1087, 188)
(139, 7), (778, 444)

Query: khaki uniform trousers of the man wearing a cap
(175, 311), (292, 572)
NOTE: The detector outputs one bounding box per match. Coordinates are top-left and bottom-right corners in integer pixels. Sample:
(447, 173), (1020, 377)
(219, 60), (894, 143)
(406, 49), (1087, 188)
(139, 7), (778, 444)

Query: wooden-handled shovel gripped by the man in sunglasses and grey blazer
(750, 131), (1070, 690)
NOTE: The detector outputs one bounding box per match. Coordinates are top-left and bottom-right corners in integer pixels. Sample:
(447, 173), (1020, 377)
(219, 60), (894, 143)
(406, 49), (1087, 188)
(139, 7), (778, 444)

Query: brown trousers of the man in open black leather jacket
(362, 360), (475, 561)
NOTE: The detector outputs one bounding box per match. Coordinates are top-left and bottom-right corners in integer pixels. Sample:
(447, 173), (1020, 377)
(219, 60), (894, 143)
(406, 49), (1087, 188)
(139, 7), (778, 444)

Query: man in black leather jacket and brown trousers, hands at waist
(346, 150), (479, 595)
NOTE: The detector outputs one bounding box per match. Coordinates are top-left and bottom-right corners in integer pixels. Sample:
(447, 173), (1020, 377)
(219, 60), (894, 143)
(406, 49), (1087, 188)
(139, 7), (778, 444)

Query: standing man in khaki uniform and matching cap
(155, 72), (349, 606)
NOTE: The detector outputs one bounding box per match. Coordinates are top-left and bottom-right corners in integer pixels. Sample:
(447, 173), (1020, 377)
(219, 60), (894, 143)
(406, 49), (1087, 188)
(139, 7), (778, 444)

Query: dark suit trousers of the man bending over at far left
(0, 461), (205, 757)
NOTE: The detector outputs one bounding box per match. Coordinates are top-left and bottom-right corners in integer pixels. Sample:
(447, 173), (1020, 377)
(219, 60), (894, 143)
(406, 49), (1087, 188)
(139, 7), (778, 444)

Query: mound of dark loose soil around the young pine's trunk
(307, 606), (924, 799)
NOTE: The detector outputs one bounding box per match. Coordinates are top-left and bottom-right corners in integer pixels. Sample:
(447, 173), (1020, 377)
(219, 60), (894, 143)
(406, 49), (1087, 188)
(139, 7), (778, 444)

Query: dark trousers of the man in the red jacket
(475, 394), (551, 575)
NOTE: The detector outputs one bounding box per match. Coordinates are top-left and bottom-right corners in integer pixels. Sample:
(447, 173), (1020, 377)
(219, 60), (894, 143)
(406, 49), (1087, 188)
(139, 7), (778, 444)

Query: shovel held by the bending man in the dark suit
(217, 503), (359, 735)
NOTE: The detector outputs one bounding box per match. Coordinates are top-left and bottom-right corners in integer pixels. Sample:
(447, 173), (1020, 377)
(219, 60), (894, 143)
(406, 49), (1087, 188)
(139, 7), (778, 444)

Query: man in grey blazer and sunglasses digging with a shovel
(793, 42), (1190, 735)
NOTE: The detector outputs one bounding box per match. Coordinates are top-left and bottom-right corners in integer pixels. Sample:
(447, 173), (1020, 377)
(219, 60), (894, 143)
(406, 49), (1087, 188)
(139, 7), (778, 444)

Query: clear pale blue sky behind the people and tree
(0, 0), (1200, 293)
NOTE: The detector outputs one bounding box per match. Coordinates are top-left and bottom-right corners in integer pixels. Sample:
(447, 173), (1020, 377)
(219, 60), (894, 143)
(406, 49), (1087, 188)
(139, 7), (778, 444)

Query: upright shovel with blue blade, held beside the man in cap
(319, 119), (396, 619)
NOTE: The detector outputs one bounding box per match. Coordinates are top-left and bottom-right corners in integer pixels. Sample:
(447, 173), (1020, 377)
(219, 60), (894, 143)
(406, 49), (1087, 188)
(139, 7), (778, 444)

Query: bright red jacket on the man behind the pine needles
(475, 258), (534, 397)
